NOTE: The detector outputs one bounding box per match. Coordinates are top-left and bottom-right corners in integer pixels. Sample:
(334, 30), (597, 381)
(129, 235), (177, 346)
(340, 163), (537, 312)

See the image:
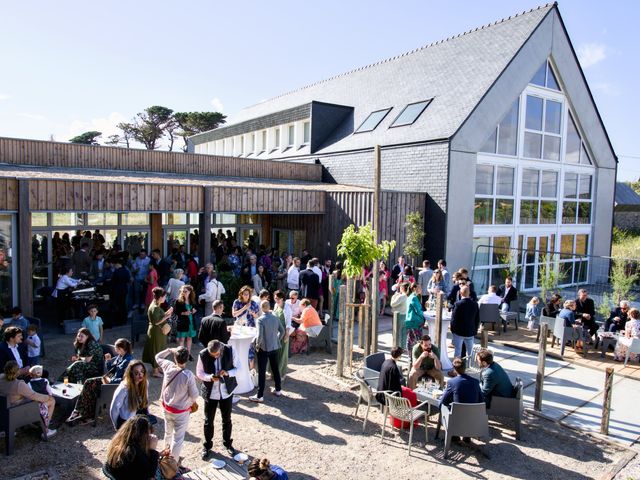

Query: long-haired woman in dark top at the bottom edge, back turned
(104, 415), (160, 480)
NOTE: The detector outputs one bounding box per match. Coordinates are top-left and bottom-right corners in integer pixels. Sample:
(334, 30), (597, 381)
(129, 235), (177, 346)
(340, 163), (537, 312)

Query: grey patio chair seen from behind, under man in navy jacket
(436, 402), (489, 458)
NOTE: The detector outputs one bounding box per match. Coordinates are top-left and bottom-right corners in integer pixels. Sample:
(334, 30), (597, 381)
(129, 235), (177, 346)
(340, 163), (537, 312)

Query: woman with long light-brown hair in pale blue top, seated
(109, 360), (155, 430)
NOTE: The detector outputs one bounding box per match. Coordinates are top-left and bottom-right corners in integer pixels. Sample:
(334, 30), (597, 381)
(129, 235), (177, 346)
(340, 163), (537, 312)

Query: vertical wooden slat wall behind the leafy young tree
(272, 192), (425, 261)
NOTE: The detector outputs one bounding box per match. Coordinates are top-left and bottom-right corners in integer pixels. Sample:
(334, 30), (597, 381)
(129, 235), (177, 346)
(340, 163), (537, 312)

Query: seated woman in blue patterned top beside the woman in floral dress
(67, 338), (133, 424)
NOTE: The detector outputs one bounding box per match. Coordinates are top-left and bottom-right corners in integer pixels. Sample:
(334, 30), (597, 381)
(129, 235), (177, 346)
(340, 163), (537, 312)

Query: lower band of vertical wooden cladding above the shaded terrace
(24, 179), (326, 214)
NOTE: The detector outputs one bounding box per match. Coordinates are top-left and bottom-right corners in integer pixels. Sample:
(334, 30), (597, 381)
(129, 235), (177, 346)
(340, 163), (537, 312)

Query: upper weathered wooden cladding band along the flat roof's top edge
(0, 137), (322, 182)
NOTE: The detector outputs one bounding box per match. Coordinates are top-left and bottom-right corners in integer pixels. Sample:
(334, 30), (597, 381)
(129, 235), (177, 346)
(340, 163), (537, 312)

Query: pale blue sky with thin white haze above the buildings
(0, 0), (640, 181)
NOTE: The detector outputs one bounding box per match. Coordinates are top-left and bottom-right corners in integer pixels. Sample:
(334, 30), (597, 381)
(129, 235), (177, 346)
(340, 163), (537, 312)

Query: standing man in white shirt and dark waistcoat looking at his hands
(196, 340), (240, 460)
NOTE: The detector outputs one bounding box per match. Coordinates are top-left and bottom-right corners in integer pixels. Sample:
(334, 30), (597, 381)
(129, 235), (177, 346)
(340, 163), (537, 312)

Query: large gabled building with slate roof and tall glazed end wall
(190, 3), (617, 290)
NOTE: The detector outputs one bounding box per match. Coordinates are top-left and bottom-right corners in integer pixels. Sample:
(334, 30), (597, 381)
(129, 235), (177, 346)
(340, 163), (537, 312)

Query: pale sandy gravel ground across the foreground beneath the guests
(0, 329), (640, 480)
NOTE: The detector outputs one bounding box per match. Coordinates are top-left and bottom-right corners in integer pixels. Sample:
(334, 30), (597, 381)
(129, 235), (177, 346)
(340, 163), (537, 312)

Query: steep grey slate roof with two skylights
(192, 3), (556, 157)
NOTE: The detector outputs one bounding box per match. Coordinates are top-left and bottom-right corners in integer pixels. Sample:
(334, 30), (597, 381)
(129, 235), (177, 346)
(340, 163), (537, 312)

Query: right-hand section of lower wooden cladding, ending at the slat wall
(211, 187), (326, 214)
